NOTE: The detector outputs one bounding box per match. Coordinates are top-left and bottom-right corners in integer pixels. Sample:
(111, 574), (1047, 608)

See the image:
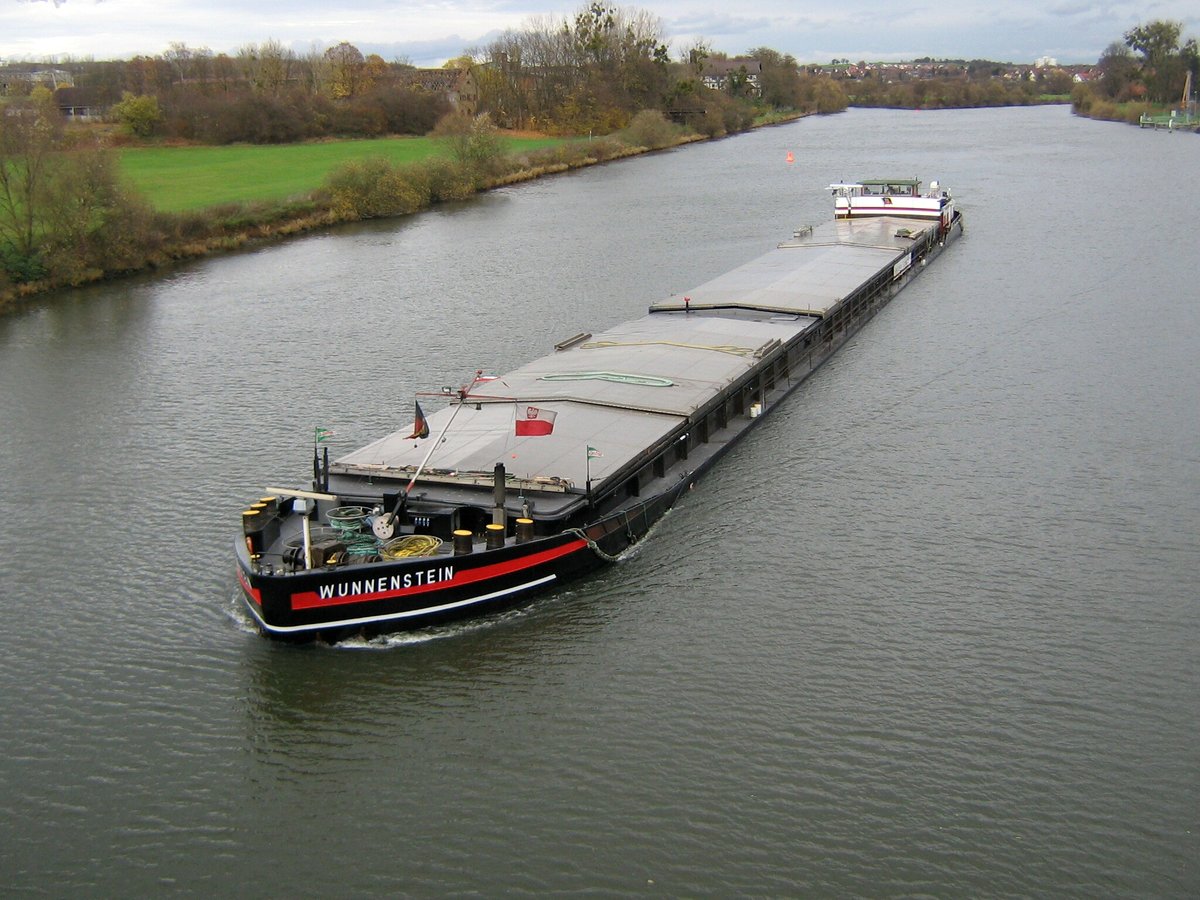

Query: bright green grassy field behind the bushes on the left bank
(120, 137), (562, 212)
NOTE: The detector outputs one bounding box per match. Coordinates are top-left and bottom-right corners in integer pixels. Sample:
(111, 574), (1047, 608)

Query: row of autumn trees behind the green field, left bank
(11, 0), (847, 144)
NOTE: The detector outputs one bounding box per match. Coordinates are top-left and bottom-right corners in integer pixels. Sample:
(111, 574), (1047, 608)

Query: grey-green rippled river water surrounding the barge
(0, 107), (1200, 898)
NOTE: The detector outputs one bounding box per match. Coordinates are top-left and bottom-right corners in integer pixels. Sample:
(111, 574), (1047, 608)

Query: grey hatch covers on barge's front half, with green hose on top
(330, 314), (816, 490)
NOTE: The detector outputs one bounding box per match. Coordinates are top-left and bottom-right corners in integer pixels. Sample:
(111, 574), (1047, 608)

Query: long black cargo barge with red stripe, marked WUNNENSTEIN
(235, 181), (962, 641)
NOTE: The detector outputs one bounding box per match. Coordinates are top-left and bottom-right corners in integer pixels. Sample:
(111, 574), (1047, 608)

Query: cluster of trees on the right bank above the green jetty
(1072, 19), (1200, 124)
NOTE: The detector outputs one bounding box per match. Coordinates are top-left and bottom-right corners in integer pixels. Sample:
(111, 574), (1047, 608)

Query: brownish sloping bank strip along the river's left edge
(0, 112), (809, 314)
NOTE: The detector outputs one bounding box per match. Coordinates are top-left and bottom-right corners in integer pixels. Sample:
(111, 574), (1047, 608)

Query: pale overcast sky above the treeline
(0, 0), (1200, 66)
